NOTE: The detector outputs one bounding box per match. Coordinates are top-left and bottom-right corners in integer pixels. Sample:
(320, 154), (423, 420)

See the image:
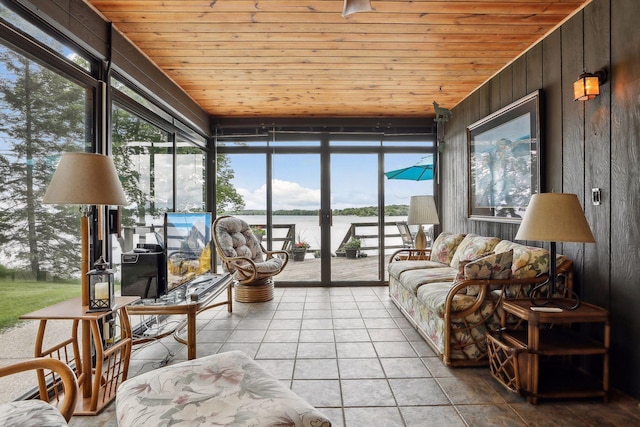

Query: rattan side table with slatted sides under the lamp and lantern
(20, 297), (139, 415)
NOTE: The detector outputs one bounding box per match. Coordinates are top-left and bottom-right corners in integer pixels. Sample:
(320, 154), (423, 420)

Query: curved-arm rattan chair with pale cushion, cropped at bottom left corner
(0, 357), (79, 427)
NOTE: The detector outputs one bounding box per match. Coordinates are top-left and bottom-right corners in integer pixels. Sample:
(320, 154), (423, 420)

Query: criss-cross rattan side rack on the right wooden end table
(487, 332), (528, 396)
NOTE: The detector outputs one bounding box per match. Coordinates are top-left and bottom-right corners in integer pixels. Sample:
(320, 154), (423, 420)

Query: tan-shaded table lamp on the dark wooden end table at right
(515, 193), (595, 309)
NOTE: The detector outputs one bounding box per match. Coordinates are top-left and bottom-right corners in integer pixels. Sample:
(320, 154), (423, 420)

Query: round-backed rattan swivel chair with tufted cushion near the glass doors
(213, 216), (289, 302)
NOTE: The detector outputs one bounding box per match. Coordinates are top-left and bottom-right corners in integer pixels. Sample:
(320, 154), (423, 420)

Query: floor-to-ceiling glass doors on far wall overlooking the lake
(216, 133), (433, 286)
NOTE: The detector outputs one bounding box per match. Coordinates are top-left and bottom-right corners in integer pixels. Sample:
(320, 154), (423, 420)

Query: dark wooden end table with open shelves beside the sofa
(501, 299), (611, 404)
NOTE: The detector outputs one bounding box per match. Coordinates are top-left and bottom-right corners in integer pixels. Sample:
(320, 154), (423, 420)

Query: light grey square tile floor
(70, 287), (640, 427)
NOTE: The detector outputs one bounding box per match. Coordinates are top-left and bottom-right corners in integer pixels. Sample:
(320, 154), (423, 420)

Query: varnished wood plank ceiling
(86, 0), (590, 118)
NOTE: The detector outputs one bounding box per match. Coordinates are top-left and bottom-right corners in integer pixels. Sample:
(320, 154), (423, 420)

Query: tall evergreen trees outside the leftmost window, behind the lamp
(0, 45), (86, 278)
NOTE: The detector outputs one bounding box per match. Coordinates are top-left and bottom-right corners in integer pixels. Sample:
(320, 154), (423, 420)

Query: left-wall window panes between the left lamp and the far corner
(111, 104), (207, 266)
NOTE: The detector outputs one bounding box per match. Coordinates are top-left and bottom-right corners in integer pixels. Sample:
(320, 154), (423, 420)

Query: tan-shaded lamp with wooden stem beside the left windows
(42, 153), (127, 306)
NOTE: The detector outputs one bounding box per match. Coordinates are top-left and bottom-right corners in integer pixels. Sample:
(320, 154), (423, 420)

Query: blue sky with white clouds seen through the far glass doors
(228, 154), (433, 210)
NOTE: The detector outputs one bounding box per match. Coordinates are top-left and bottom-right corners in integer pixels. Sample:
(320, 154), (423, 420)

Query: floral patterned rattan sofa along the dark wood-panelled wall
(388, 232), (573, 366)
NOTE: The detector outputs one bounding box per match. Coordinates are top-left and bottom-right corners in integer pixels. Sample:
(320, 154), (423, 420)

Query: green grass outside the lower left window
(0, 279), (81, 332)
